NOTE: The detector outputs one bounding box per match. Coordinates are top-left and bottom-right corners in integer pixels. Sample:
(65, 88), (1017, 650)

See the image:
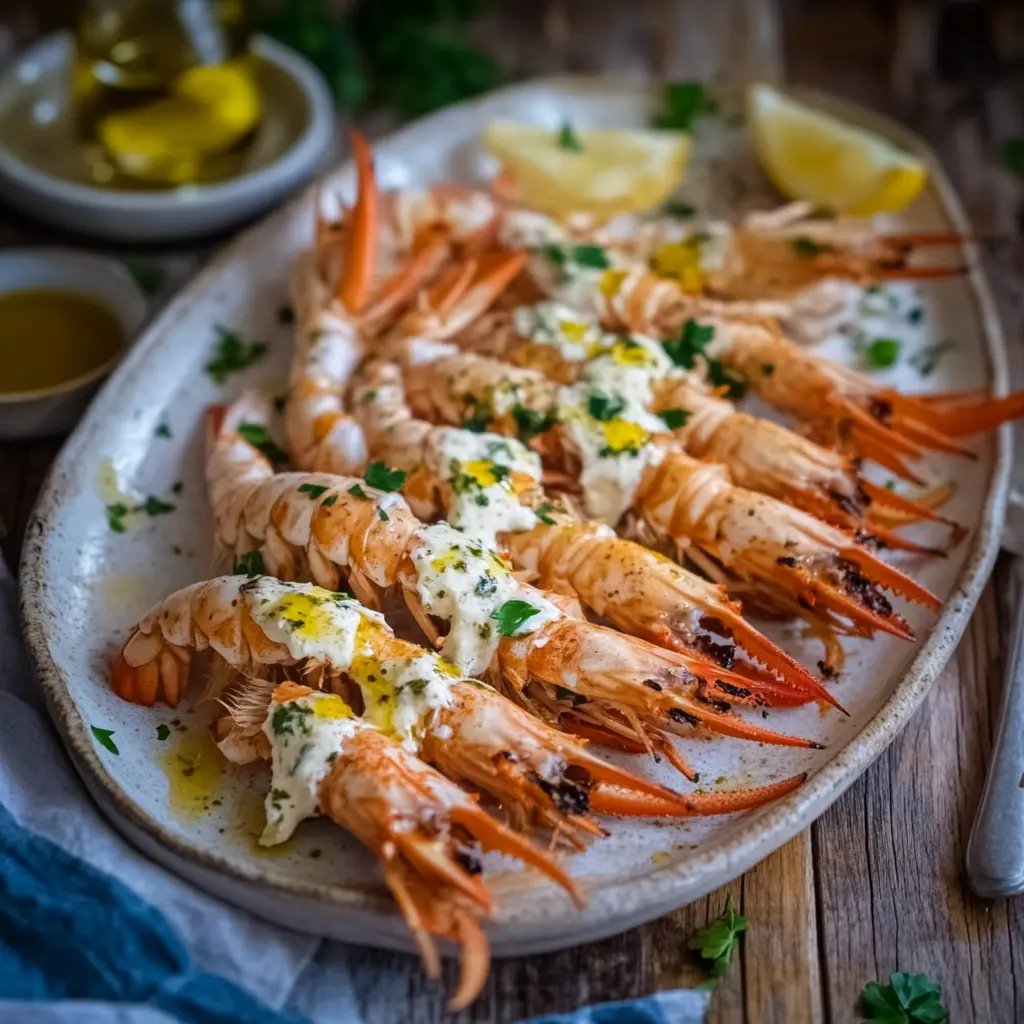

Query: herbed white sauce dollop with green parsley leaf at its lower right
(412, 522), (561, 676)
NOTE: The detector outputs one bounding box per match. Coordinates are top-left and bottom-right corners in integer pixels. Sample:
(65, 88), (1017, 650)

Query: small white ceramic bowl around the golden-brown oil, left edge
(0, 249), (146, 440)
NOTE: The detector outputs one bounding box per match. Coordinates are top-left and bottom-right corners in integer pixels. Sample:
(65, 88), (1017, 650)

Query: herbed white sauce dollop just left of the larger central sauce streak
(426, 429), (541, 548)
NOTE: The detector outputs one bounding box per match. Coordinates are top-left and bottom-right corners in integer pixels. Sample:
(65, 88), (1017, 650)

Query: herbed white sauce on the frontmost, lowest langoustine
(259, 693), (362, 846)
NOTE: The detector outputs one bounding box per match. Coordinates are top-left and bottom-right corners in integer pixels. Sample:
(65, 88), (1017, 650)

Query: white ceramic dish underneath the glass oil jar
(0, 33), (335, 242)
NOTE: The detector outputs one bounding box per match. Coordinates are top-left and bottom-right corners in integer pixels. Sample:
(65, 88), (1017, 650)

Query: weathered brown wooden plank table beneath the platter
(0, 0), (1024, 1024)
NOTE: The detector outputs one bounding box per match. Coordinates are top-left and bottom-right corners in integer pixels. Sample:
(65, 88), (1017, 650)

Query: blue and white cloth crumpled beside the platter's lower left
(0, 560), (708, 1024)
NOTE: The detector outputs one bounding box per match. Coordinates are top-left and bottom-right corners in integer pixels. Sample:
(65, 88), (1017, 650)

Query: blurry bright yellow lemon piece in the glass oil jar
(96, 58), (260, 184)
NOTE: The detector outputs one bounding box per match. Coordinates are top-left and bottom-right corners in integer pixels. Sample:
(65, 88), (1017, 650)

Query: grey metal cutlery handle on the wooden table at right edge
(967, 589), (1024, 899)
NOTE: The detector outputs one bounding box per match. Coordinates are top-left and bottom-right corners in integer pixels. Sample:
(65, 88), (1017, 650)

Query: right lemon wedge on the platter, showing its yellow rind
(746, 85), (928, 216)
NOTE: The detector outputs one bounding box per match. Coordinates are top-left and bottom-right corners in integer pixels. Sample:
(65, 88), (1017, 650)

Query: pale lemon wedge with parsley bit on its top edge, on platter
(483, 121), (691, 217)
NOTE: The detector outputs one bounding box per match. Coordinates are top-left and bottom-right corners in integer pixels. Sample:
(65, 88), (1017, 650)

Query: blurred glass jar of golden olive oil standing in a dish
(74, 0), (261, 188)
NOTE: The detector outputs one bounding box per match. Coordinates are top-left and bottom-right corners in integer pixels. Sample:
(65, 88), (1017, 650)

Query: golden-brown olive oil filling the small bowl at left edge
(0, 288), (125, 399)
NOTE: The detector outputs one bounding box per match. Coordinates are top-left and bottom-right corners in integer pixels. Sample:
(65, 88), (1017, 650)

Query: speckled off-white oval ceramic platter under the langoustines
(22, 79), (1009, 953)
